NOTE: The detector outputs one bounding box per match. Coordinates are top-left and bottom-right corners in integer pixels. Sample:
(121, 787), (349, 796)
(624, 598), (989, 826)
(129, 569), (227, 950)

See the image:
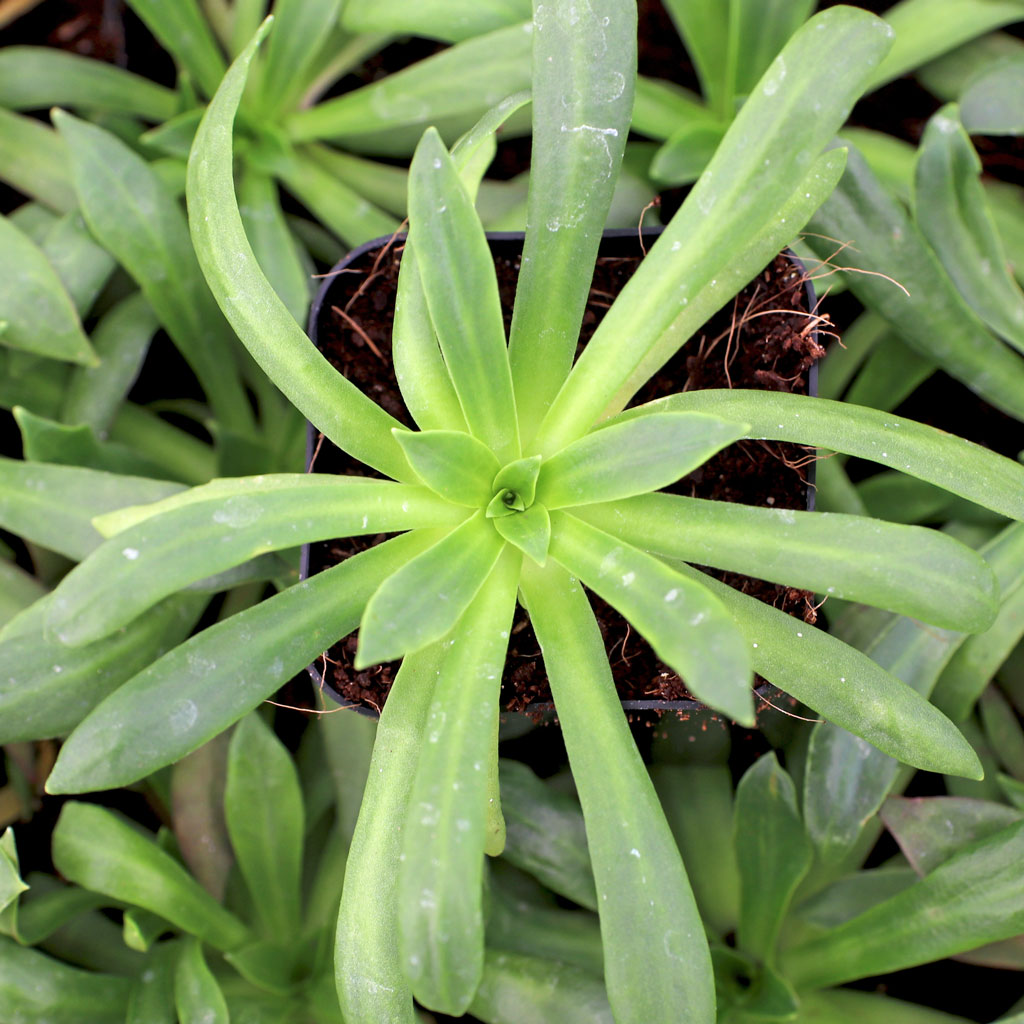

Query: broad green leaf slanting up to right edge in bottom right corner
(780, 822), (1024, 988)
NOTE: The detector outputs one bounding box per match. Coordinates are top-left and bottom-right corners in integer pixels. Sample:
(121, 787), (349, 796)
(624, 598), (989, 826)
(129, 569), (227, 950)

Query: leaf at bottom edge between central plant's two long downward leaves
(469, 949), (618, 1024)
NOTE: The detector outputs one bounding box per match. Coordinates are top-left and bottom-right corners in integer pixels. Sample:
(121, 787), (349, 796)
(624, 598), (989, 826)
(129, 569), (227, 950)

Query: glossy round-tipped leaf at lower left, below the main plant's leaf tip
(53, 801), (248, 949)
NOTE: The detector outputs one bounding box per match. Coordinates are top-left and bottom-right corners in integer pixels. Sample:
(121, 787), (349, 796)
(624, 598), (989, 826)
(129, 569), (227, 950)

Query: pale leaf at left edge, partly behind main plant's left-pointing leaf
(0, 459), (182, 561)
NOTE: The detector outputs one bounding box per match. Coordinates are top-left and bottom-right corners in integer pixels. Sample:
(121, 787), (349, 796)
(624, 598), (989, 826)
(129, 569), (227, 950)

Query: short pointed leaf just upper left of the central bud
(395, 430), (501, 508)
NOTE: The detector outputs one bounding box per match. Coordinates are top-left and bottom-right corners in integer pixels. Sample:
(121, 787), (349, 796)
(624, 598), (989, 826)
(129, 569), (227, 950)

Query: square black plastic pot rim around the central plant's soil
(300, 227), (817, 718)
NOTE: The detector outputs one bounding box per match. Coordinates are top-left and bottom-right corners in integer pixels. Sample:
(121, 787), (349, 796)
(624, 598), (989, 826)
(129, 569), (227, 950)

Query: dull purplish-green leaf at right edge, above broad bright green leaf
(879, 797), (1024, 877)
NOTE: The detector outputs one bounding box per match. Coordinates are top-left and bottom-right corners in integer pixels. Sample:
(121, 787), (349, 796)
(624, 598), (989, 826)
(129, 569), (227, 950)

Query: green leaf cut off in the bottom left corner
(0, 936), (131, 1024)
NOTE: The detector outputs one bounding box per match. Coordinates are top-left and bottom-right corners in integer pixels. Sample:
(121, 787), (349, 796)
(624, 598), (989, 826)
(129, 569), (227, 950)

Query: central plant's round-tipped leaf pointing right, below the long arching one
(574, 489), (997, 632)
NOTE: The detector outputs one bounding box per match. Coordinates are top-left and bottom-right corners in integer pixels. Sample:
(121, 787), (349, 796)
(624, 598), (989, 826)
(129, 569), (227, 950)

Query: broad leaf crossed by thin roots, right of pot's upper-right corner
(806, 142), (1024, 419)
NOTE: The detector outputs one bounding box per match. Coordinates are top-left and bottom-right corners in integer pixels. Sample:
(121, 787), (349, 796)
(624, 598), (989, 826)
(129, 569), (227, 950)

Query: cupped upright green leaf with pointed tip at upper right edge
(913, 103), (1024, 352)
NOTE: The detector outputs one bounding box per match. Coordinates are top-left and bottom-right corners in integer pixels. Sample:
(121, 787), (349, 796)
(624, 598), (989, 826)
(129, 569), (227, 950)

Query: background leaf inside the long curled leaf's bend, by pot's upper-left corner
(239, 165), (312, 327)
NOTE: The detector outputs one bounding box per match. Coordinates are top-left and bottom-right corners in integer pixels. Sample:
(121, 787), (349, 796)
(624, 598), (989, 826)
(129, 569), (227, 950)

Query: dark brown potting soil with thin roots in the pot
(301, 231), (822, 711)
